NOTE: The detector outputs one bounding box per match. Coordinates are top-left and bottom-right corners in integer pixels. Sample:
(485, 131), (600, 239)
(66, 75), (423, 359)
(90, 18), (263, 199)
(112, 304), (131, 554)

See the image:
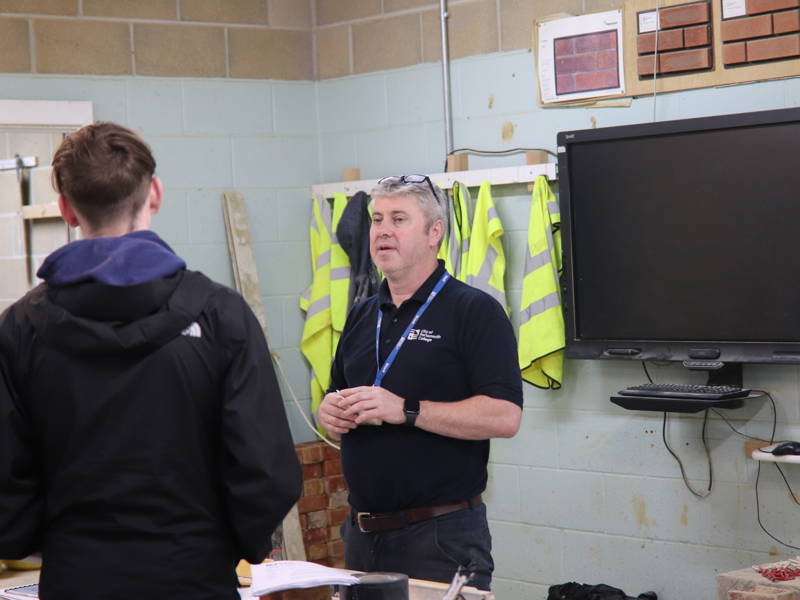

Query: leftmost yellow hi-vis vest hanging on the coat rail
(300, 197), (333, 420)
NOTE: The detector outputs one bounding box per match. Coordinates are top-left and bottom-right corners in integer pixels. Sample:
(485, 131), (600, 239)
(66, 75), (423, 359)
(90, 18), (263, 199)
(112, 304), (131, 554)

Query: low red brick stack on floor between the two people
(295, 442), (350, 567)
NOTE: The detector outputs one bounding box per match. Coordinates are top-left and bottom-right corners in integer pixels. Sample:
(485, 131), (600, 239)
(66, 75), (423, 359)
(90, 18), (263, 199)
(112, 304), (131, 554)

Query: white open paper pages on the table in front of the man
(250, 560), (358, 596)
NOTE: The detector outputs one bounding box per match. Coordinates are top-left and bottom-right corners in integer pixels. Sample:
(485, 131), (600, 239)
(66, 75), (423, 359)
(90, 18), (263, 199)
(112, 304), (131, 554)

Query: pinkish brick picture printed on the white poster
(554, 31), (620, 94)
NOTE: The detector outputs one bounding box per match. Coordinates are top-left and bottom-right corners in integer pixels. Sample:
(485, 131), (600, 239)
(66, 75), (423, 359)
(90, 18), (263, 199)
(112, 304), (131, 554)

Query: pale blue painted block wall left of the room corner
(0, 74), (319, 442)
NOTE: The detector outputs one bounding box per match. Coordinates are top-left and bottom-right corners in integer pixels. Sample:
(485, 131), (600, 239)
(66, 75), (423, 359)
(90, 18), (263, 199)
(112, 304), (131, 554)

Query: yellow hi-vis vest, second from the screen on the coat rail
(466, 181), (508, 314)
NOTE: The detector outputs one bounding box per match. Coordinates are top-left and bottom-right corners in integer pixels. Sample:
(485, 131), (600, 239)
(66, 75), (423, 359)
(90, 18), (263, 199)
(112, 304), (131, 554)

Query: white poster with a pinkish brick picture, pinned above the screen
(537, 10), (625, 103)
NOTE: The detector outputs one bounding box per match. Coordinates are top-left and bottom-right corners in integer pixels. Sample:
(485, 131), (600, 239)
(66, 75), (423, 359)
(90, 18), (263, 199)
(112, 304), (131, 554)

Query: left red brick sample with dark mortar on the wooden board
(636, 2), (713, 77)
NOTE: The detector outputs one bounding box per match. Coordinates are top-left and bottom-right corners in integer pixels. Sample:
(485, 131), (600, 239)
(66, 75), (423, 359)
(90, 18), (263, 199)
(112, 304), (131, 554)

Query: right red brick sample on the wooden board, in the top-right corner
(722, 0), (800, 67)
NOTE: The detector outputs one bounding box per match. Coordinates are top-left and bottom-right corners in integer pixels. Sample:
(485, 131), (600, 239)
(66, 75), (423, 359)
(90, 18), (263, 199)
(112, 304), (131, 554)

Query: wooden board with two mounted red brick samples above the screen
(623, 0), (800, 96)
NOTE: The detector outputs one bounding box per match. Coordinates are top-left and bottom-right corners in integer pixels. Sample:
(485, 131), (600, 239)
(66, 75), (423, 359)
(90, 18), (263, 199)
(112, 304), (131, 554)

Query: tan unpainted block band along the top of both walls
(0, 0), (623, 80)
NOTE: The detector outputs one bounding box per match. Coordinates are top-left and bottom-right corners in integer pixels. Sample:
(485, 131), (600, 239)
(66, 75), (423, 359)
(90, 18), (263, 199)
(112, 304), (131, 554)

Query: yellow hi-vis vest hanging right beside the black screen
(519, 175), (564, 390)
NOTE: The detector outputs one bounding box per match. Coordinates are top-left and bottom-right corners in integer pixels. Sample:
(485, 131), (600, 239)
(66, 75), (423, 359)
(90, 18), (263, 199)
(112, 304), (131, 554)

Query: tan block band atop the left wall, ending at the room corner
(0, 0), (314, 80)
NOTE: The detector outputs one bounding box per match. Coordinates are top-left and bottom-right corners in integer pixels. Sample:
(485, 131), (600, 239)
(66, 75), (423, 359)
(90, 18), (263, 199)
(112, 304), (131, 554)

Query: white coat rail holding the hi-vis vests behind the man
(311, 163), (557, 198)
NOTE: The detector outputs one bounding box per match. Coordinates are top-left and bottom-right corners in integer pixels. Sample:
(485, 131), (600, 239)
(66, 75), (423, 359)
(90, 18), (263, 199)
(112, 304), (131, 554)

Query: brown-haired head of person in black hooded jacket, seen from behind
(53, 121), (156, 227)
